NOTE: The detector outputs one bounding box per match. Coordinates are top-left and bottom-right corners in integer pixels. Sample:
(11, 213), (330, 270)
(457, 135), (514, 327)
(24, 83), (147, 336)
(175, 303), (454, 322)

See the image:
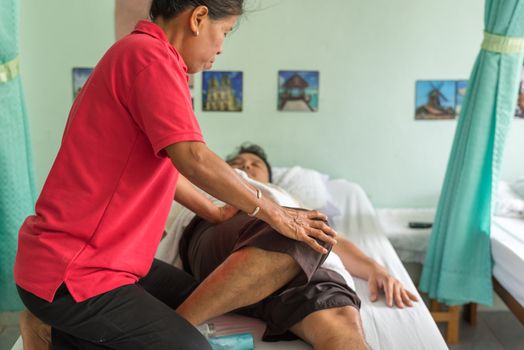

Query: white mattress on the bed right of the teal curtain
(491, 217), (524, 307)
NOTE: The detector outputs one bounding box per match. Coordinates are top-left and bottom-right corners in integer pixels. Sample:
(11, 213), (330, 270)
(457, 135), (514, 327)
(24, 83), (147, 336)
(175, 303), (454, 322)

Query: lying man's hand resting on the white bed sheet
(368, 265), (418, 309)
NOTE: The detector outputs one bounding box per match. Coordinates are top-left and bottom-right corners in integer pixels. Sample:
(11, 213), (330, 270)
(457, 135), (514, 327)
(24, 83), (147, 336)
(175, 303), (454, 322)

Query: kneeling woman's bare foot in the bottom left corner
(20, 310), (51, 350)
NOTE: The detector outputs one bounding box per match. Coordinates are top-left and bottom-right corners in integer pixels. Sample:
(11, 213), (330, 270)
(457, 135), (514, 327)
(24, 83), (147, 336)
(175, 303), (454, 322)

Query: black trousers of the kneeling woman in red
(18, 260), (211, 350)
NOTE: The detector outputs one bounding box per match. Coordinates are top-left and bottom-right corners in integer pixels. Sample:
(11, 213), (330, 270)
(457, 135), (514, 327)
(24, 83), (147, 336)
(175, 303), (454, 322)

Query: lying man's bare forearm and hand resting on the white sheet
(333, 237), (418, 308)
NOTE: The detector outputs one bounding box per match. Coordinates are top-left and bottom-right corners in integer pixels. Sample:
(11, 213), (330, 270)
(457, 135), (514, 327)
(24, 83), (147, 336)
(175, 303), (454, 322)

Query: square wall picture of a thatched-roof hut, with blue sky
(277, 71), (320, 112)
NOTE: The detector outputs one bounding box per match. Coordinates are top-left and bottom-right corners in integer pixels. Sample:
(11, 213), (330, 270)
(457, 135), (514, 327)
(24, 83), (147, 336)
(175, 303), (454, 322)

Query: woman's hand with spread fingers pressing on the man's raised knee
(264, 207), (337, 254)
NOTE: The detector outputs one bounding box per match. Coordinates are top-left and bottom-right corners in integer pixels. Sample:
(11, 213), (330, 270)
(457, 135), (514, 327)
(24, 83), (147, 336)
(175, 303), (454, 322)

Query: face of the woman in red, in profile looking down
(181, 11), (238, 74)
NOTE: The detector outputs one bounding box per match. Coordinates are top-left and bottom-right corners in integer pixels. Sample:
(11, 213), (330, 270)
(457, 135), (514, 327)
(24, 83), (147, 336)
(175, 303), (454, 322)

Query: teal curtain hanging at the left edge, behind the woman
(0, 0), (35, 311)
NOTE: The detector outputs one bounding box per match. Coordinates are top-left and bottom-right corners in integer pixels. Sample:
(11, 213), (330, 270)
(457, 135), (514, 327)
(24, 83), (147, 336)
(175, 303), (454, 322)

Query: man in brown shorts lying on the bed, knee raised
(157, 144), (417, 350)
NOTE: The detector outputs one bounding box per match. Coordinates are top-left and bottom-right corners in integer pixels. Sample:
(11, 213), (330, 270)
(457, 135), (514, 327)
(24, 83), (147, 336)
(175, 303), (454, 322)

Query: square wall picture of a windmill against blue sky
(415, 80), (457, 120)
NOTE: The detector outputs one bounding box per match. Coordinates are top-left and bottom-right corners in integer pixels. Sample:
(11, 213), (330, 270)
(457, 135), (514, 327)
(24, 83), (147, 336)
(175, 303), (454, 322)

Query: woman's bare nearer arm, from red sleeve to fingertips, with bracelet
(166, 142), (336, 254)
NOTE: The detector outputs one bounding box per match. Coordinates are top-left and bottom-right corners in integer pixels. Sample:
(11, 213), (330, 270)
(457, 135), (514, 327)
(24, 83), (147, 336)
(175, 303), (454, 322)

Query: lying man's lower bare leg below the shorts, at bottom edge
(290, 306), (369, 350)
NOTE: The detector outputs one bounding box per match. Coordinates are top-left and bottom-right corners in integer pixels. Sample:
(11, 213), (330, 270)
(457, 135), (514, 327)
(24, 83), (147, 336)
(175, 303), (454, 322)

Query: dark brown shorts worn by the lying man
(180, 213), (360, 341)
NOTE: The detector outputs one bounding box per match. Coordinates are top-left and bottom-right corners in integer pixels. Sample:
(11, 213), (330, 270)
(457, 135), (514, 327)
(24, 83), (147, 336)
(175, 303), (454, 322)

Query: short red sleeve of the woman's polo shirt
(128, 59), (204, 157)
